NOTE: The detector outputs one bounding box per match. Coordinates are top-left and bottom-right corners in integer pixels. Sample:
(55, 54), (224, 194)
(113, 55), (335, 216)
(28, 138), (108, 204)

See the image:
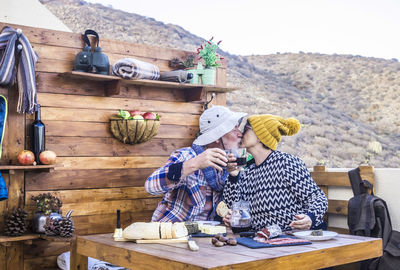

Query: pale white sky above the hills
(87, 0), (400, 60)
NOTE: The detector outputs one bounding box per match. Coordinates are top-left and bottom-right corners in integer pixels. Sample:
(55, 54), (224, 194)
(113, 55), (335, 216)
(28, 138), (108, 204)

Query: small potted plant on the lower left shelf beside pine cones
(31, 193), (62, 233)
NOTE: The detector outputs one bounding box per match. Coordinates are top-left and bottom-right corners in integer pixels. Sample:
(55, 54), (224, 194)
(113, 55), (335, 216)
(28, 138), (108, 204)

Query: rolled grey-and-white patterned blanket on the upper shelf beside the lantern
(112, 58), (160, 80)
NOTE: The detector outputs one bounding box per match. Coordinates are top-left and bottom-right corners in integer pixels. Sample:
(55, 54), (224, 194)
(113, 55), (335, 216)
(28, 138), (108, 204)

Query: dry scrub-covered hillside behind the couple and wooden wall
(41, 0), (400, 167)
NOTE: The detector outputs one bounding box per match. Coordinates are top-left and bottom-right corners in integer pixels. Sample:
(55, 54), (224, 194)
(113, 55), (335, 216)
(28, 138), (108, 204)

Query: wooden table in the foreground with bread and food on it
(71, 234), (382, 270)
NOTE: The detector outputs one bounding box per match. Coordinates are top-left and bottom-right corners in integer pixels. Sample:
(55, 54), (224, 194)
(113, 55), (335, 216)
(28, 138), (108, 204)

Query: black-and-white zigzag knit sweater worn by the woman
(223, 151), (328, 230)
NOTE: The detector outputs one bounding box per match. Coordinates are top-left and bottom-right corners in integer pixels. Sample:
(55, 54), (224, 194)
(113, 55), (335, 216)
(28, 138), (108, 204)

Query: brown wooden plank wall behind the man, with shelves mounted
(0, 23), (226, 270)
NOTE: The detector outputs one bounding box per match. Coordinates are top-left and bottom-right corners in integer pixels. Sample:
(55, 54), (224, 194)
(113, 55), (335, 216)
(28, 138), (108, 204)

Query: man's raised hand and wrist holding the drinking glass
(182, 148), (228, 178)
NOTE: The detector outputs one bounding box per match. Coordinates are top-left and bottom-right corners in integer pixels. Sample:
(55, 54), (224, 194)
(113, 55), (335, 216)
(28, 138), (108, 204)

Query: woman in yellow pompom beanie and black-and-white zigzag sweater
(223, 114), (328, 230)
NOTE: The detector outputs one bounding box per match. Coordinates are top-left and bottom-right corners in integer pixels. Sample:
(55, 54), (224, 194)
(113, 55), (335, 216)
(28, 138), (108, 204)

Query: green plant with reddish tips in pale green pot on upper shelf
(197, 37), (224, 85)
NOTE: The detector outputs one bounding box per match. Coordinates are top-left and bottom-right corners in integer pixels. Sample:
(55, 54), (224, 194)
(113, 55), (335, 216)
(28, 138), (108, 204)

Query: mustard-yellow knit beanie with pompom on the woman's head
(248, 114), (300, 150)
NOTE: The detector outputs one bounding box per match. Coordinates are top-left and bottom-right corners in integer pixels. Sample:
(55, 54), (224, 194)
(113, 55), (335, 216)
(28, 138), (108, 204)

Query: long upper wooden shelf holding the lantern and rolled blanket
(59, 71), (239, 101)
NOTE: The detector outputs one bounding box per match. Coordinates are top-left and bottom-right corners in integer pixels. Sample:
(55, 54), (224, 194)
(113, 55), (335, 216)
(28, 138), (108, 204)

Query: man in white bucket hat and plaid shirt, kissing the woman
(145, 106), (247, 222)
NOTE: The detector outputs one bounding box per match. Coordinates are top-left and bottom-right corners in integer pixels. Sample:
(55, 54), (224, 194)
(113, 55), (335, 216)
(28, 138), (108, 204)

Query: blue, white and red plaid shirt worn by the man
(145, 147), (227, 222)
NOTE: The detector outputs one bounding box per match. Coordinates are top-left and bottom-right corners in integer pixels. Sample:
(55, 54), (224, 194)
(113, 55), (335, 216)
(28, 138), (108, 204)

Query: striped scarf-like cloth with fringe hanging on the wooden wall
(0, 26), (38, 114)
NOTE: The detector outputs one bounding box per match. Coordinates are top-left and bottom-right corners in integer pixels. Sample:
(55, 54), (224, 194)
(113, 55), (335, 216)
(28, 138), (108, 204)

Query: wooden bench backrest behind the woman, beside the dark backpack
(311, 166), (375, 234)
